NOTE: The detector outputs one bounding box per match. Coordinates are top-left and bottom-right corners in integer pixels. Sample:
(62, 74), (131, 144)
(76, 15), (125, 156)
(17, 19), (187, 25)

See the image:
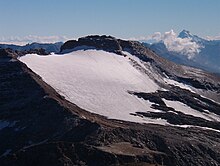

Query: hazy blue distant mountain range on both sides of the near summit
(0, 30), (220, 74)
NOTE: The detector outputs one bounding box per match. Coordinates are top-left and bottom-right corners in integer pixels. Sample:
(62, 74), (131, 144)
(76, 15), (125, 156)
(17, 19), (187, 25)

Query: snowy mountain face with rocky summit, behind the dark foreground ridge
(20, 36), (220, 129)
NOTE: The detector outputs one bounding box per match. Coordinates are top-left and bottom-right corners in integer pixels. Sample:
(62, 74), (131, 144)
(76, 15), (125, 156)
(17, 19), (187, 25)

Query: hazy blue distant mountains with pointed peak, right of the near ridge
(143, 30), (220, 74)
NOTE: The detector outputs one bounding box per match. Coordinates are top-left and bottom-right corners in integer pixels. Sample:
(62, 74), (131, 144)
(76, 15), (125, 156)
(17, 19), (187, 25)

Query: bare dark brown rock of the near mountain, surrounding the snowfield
(0, 37), (220, 166)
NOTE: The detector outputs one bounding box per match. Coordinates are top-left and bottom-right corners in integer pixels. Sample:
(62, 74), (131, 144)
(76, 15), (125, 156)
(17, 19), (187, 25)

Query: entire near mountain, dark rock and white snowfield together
(0, 32), (220, 166)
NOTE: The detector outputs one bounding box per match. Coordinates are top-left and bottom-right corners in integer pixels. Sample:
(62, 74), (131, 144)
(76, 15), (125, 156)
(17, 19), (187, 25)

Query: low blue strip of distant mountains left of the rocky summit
(0, 42), (63, 53)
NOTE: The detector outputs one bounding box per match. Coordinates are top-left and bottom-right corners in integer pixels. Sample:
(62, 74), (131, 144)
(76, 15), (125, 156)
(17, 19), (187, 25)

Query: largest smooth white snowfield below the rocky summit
(20, 50), (168, 125)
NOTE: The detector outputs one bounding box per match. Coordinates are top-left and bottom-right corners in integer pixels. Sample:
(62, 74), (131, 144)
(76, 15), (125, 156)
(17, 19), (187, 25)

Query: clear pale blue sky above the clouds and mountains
(0, 0), (220, 42)
